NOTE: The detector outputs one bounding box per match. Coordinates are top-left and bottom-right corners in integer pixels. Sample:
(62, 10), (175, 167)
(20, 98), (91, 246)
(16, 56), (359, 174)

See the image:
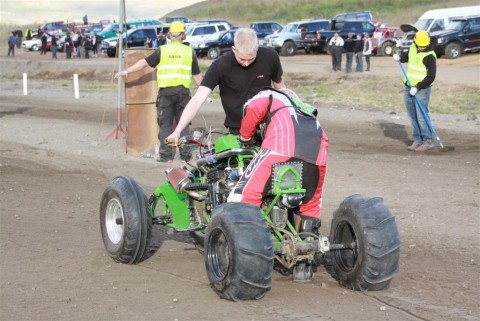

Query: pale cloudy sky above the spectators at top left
(0, 0), (200, 25)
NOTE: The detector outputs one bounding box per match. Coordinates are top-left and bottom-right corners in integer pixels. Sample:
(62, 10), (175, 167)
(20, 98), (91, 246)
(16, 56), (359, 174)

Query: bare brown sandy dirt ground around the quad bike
(0, 49), (480, 321)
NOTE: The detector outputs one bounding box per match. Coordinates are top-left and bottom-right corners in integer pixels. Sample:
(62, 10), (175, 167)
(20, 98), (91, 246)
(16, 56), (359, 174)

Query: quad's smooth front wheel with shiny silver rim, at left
(100, 176), (152, 264)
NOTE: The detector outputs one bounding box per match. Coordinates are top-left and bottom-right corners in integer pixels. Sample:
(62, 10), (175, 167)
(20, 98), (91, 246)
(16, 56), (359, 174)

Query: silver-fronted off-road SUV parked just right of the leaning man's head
(263, 19), (330, 56)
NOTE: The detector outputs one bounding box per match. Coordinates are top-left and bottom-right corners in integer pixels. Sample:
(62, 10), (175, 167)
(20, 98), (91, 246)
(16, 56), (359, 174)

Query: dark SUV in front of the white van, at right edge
(431, 16), (480, 59)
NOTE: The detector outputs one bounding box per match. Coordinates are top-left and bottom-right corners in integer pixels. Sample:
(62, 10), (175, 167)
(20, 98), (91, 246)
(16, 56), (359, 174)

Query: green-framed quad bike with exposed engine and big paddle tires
(100, 130), (400, 301)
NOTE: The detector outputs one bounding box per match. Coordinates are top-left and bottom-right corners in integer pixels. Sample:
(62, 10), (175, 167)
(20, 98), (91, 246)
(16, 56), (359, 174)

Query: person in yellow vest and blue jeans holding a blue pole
(393, 30), (437, 152)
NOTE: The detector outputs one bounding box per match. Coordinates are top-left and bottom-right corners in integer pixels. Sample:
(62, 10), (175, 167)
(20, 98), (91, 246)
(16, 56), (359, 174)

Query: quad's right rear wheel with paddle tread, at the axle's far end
(330, 195), (400, 291)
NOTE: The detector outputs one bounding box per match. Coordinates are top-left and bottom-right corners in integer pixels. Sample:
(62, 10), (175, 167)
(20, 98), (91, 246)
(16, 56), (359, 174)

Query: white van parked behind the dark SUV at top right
(399, 6), (480, 51)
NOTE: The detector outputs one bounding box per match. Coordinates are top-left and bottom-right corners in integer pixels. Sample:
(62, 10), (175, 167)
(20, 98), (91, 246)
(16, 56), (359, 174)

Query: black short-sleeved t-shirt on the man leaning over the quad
(201, 47), (283, 132)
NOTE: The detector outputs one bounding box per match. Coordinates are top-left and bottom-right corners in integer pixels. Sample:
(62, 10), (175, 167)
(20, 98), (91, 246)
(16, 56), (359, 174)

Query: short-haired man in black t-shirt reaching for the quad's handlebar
(168, 28), (285, 140)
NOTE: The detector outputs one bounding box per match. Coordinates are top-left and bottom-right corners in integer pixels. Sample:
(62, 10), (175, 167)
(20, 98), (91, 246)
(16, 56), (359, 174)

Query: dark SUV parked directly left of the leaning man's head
(192, 30), (235, 59)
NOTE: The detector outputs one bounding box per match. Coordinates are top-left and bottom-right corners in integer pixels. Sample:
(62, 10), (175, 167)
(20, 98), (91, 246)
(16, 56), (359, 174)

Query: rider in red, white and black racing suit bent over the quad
(228, 89), (328, 235)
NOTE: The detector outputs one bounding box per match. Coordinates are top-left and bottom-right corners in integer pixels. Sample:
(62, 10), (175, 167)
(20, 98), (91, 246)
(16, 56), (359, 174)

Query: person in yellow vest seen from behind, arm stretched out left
(115, 21), (203, 163)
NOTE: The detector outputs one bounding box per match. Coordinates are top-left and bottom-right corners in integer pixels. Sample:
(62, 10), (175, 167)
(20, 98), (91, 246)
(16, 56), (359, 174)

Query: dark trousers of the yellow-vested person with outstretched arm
(157, 91), (191, 159)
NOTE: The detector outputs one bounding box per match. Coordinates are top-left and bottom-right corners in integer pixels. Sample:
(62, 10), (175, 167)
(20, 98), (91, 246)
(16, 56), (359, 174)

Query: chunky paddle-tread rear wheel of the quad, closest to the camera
(205, 203), (275, 301)
